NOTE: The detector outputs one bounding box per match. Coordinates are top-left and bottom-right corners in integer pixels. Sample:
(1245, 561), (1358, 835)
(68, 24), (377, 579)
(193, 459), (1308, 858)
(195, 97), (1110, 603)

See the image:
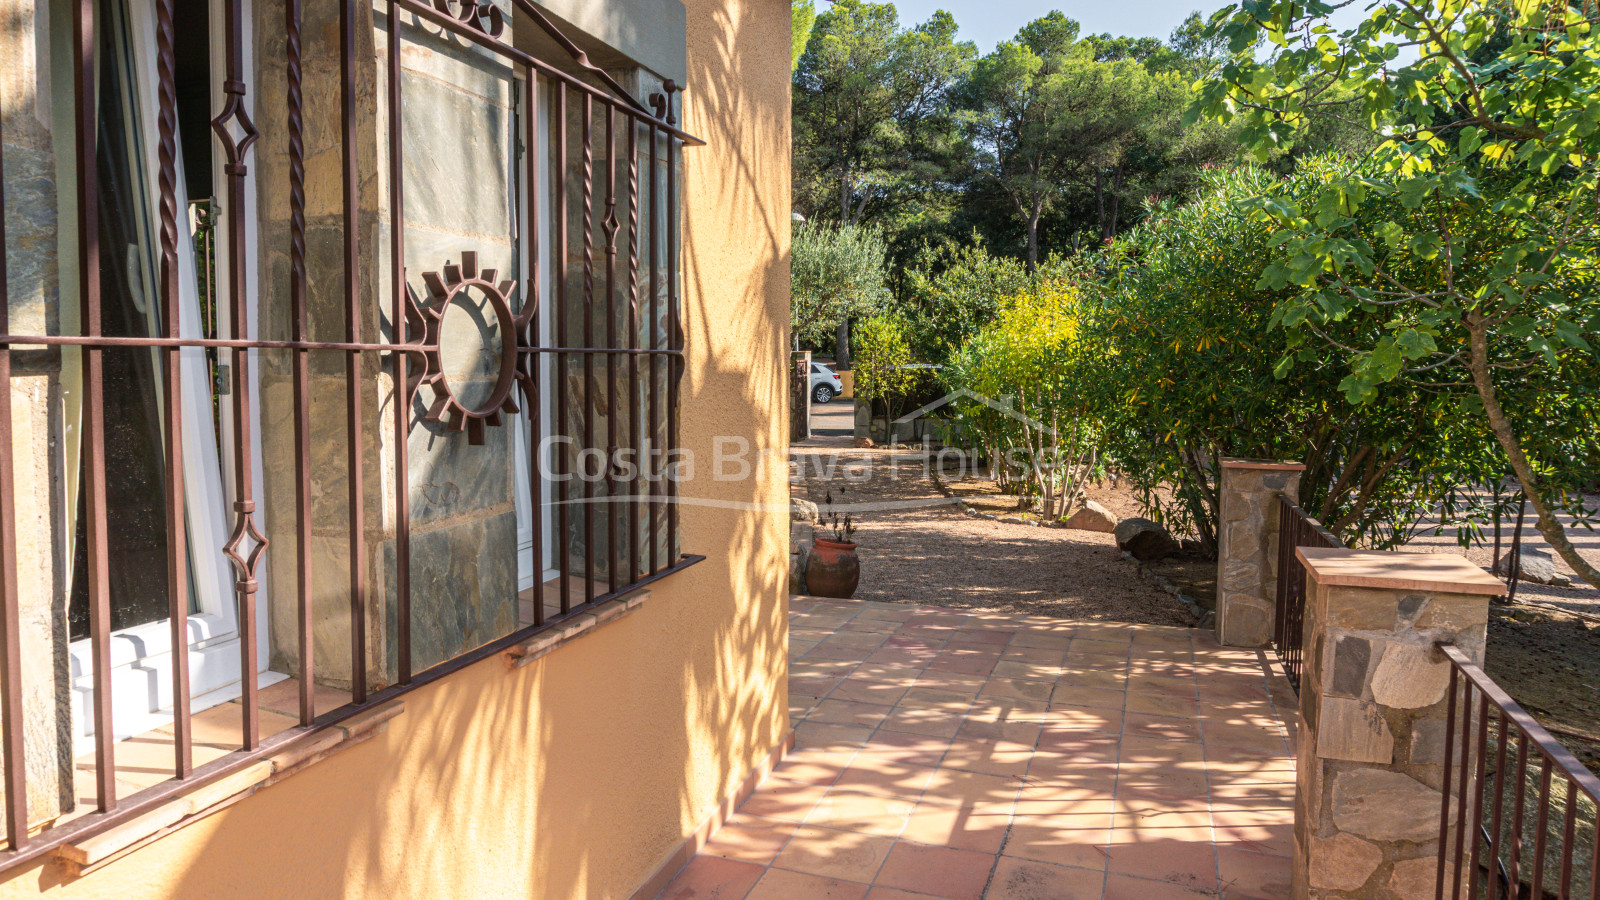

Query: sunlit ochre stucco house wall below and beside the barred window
(0, 0), (790, 900)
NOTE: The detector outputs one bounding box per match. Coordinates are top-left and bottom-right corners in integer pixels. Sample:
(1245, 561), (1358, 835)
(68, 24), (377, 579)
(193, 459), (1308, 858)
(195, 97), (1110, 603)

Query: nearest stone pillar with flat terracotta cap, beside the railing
(1291, 548), (1506, 900)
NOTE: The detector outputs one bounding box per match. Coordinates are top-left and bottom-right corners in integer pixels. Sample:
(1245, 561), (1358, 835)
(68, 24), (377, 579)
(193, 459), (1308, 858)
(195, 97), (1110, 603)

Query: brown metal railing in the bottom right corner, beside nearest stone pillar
(1435, 644), (1600, 900)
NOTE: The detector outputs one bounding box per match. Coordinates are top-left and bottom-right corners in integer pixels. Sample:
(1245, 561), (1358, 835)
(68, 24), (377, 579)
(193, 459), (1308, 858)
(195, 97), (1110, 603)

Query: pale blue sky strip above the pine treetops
(883, 0), (1227, 53)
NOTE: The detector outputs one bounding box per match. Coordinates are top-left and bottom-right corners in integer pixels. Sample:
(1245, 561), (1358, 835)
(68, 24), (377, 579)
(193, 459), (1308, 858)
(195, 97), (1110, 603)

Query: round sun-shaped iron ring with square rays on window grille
(411, 250), (525, 444)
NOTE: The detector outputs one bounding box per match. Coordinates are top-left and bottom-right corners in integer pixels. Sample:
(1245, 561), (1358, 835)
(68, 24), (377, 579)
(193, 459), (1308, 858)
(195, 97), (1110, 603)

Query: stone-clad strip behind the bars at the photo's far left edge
(0, 0), (80, 826)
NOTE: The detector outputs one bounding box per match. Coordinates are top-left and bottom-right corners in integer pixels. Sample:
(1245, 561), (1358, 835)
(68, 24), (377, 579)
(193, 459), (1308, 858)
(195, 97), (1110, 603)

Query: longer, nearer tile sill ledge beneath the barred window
(54, 700), (405, 879)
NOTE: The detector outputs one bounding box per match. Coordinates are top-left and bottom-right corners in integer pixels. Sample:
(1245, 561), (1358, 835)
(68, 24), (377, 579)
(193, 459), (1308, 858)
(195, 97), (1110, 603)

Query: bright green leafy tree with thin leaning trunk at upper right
(1194, 0), (1600, 586)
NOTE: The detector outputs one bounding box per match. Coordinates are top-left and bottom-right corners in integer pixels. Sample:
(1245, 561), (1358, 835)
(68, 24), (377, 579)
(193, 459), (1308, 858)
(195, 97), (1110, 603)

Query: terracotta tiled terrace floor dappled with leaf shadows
(661, 597), (1294, 900)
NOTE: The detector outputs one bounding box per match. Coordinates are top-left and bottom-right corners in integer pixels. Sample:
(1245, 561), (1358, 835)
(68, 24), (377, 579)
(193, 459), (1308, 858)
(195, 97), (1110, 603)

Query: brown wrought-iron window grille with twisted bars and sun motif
(0, 0), (704, 870)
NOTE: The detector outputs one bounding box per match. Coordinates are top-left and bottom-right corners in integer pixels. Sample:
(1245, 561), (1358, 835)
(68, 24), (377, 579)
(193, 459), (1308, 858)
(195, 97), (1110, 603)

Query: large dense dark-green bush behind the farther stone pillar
(1091, 157), (1491, 549)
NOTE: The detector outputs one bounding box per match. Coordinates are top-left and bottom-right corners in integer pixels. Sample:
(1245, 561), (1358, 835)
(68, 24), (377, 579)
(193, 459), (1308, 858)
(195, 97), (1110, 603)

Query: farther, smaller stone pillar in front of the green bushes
(1216, 458), (1306, 647)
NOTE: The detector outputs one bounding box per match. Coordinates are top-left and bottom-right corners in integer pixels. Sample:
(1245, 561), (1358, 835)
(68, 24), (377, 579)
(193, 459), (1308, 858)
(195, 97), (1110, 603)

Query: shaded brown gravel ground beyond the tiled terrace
(792, 447), (1189, 625)
